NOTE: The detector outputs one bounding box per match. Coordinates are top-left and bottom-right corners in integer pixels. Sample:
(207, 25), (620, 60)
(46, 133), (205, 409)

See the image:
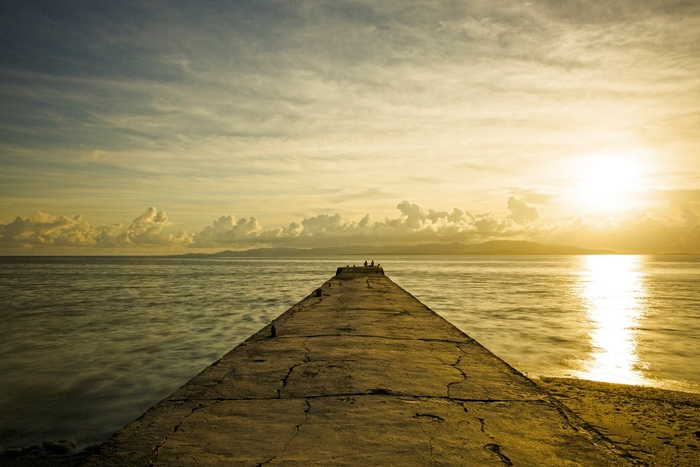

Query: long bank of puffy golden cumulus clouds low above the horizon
(0, 197), (700, 253)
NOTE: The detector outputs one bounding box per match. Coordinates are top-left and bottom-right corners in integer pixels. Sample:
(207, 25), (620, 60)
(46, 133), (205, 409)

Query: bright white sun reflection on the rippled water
(578, 255), (649, 384)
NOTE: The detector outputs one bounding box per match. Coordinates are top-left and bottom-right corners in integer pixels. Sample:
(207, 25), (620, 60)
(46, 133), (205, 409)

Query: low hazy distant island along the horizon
(177, 240), (616, 258)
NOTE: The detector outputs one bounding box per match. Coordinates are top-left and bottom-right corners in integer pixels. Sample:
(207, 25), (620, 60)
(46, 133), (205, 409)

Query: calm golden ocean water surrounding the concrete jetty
(0, 255), (700, 458)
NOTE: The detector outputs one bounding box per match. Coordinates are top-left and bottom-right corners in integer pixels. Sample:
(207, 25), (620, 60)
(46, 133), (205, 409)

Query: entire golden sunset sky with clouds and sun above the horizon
(0, 0), (700, 255)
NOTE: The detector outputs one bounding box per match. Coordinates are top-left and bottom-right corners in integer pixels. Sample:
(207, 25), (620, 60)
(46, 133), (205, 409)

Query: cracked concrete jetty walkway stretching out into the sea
(87, 267), (630, 467)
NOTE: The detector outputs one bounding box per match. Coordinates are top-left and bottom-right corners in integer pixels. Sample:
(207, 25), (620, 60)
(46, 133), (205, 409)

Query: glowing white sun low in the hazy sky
(574, 155), (640, 212)
